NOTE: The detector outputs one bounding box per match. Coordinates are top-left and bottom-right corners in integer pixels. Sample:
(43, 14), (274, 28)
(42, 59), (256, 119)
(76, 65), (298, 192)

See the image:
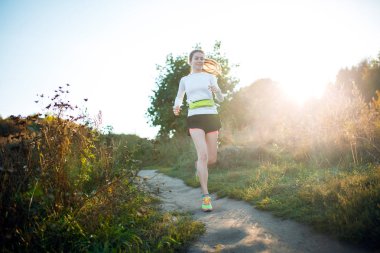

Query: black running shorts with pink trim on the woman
(187, 114), (222, 135)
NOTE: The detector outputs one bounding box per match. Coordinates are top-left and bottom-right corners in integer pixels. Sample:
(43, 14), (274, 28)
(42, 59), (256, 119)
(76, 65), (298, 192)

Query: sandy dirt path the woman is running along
(139, 170), (368, 253)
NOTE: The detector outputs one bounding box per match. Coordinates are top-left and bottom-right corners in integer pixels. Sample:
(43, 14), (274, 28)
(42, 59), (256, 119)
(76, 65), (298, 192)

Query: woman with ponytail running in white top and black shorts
(173, 49), (223, 212)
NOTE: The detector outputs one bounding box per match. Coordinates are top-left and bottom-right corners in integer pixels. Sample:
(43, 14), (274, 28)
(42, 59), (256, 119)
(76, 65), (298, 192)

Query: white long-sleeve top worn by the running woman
(174, 72), (224, 116)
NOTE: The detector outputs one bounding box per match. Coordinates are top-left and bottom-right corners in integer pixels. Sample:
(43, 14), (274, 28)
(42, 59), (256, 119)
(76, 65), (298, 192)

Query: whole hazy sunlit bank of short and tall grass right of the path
(153, 86), (380, 248)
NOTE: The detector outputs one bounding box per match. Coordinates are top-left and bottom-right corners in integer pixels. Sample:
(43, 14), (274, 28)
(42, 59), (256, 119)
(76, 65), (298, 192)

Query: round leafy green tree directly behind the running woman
(147, 41), (239, 137)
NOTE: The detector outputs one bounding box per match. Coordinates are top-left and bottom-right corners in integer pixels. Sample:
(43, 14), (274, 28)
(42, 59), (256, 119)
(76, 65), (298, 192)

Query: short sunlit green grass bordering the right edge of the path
(151, 139), (380, 250)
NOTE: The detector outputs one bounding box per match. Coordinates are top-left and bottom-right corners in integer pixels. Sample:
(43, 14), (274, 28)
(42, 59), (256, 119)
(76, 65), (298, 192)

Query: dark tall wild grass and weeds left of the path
(0, 87), (204, 252)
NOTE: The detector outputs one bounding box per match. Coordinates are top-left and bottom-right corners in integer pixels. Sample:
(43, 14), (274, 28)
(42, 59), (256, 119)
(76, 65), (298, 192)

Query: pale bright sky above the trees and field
(0, 0), (380, 138)
